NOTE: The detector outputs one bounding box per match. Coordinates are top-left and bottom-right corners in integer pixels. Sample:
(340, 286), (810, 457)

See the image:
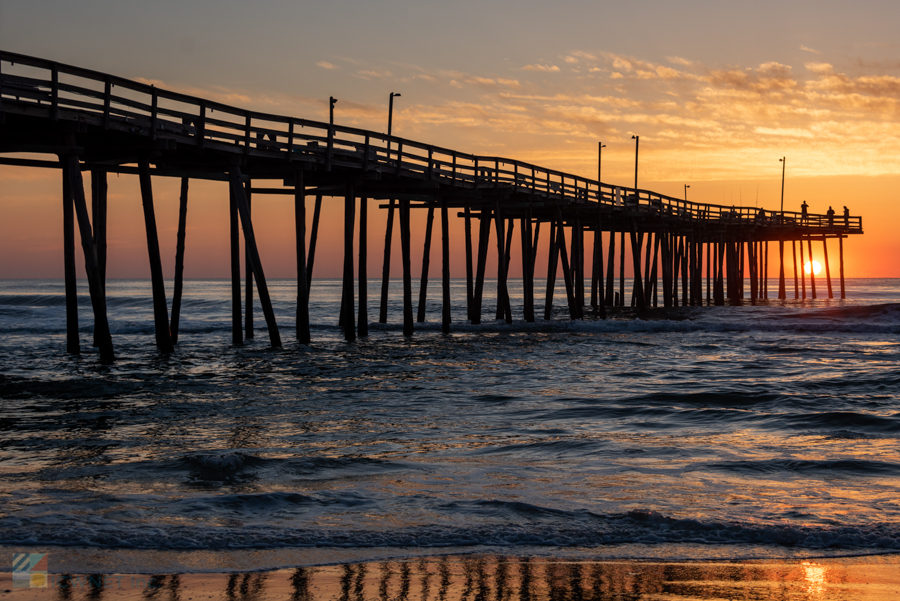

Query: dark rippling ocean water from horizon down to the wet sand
(0, 280), (900, 573)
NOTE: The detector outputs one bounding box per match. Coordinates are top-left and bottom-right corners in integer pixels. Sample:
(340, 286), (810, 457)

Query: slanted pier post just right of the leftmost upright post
(59, 152), (115, 363)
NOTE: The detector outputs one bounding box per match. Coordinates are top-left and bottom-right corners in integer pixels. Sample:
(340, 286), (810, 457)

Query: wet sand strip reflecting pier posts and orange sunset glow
(8, 556), (900, 601)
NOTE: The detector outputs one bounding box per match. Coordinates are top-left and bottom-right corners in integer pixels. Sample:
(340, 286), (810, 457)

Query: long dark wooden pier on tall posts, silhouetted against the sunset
(0, 52), (862, 360)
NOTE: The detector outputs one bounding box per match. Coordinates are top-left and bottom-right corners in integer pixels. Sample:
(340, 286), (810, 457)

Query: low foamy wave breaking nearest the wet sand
(0, 506), (900, 551)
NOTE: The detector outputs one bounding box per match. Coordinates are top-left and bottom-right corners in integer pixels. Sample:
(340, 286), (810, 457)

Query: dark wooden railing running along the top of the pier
(0, 51), (862, 233)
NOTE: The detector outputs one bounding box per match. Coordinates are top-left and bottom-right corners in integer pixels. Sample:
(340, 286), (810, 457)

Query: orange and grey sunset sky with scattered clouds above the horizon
(0, 0), (900, 278)
